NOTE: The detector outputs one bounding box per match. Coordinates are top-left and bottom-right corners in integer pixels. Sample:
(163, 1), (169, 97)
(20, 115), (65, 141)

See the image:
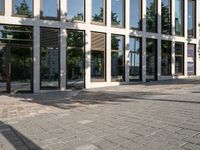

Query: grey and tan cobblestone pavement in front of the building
(0, 78), (200, 150)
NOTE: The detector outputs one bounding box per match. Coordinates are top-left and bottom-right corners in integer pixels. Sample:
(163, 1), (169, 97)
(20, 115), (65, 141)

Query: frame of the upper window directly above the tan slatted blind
(90, 0), (107, 26)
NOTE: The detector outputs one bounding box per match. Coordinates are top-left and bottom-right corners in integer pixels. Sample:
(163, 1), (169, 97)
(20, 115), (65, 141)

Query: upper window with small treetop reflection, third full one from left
(67, 0), (85, 21)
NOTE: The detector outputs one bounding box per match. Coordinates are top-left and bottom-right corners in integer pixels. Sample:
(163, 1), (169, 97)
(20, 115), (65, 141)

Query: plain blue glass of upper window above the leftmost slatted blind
(42, 0), (58, 18)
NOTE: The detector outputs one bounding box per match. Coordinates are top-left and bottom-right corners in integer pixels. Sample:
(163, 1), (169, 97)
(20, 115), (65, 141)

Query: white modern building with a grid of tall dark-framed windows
(0, 0), (200, 93)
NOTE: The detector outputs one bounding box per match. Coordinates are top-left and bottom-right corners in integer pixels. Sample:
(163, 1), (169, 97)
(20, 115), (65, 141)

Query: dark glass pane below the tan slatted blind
(91, 51), (104, 80)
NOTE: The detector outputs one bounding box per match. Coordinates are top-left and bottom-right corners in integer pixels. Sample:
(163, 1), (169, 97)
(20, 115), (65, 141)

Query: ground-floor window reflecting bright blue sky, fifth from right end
(129, 37), (142, 81)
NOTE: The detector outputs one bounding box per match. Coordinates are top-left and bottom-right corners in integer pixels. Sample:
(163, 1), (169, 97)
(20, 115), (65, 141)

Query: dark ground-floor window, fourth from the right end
(146, 39), (157, 80)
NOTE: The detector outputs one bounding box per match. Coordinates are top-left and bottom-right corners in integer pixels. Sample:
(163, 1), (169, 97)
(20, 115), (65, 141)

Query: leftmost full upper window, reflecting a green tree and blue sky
(13, 0), (33, 17)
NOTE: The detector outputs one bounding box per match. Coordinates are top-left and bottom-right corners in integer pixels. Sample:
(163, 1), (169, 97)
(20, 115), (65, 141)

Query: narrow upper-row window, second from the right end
(175, 0), (184, 36)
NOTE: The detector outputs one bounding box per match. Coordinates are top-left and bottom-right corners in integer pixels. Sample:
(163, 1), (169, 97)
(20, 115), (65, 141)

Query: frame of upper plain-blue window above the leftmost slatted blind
(40, 0), (61, 21)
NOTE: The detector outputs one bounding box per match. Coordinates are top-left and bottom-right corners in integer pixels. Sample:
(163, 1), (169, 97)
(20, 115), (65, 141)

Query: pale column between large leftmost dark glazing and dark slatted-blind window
(33, 26), (40, 93)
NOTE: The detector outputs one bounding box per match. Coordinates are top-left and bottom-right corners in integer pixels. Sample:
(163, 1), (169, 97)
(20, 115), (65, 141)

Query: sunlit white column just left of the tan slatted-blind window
(85, 30), (91, 88)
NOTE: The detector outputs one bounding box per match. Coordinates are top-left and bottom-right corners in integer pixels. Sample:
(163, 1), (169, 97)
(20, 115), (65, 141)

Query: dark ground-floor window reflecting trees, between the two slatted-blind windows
(67, 31), (84, 88)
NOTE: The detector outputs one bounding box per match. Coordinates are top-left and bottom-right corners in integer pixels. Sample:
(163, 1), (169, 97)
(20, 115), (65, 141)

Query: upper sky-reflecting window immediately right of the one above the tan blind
(111, 0), (125, 27)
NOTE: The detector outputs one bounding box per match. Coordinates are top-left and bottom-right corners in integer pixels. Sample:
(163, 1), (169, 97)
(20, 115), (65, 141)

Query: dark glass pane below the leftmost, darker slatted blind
(40, 47), (60, 87)
